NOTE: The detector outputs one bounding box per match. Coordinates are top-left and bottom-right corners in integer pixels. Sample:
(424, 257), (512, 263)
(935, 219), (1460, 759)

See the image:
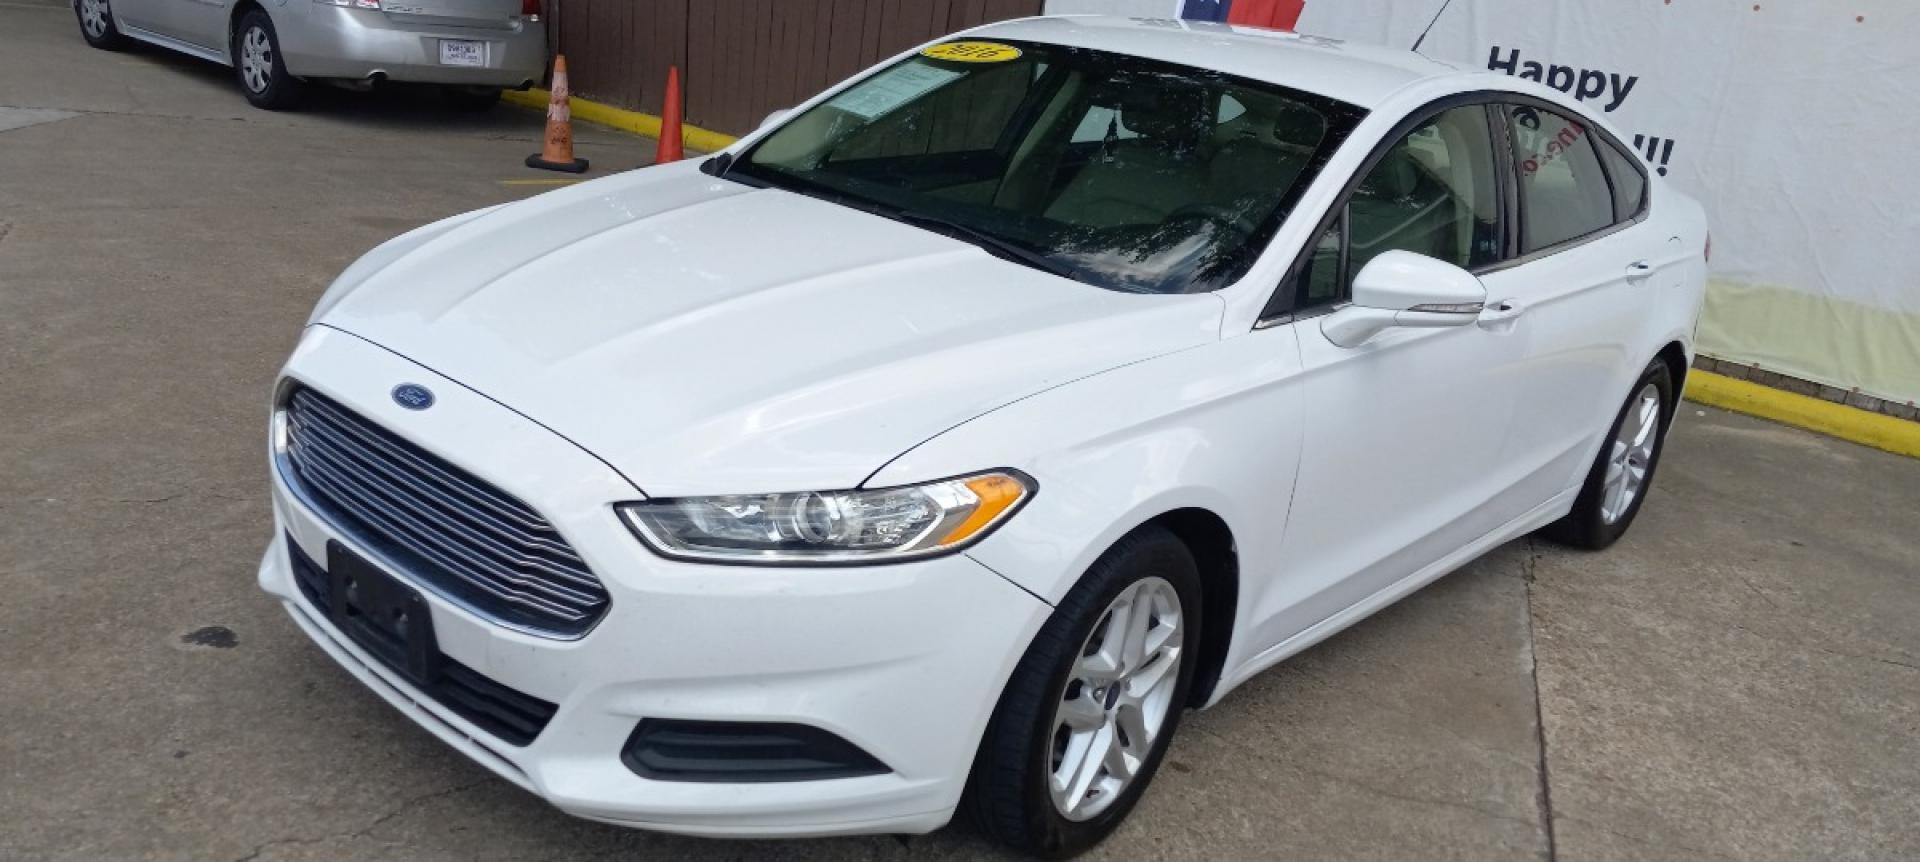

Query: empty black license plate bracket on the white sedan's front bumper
(326, 541), (440, 687)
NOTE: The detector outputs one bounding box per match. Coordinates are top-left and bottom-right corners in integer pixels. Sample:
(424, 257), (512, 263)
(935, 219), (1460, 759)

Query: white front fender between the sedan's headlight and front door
(866, 318), (1306, 683)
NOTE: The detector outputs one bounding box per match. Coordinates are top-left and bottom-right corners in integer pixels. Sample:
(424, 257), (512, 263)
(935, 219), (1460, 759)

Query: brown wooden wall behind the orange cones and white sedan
(547, 0), (1043, 134)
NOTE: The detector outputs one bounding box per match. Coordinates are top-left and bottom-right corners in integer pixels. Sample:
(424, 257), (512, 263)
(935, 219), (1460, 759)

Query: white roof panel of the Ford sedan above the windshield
(968, 15), (1463, 109)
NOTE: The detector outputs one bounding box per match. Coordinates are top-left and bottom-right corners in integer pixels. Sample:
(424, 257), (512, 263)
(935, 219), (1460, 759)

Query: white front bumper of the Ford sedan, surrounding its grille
(259, 328), (1050, 835)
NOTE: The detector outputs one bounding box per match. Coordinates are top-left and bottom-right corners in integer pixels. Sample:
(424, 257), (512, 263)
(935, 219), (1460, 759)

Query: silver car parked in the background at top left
(73, 0), (547, 109)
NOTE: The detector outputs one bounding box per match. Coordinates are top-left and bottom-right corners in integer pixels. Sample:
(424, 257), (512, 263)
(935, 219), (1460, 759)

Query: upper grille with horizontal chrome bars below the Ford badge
(284, 388), (607, 637)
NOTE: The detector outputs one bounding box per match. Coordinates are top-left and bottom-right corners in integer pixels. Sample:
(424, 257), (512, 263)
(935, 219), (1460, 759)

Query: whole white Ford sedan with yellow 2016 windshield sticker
(259, 17), (1707, 856)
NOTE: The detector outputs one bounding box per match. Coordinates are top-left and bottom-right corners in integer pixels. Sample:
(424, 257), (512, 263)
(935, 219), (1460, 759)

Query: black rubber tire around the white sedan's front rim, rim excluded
(962, 526), (1202, 858)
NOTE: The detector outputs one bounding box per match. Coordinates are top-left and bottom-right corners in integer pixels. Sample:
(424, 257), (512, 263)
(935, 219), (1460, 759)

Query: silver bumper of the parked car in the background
(275, 0), (547, 88)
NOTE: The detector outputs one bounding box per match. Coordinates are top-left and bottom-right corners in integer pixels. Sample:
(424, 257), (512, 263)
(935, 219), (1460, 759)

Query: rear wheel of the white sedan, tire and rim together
(1542, 359), (1674, 551)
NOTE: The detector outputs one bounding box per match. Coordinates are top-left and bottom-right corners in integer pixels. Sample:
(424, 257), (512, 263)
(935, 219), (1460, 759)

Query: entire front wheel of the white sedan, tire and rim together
(966, 526), (1200, 858)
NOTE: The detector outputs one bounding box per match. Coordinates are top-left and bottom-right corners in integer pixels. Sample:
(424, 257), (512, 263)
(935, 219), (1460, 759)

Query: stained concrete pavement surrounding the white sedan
(0, 0), (1920, 860)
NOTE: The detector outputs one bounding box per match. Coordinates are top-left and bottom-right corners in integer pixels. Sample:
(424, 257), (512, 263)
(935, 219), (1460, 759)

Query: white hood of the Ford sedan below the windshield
(317, 163), (1221, 497)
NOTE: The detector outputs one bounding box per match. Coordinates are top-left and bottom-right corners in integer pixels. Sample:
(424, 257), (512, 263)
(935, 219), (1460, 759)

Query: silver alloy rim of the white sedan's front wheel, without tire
(1046, 578), (1185, 820)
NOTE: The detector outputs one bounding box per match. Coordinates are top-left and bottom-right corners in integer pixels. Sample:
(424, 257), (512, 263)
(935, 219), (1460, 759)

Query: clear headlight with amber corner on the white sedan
(618, 470), (1033, 564)
